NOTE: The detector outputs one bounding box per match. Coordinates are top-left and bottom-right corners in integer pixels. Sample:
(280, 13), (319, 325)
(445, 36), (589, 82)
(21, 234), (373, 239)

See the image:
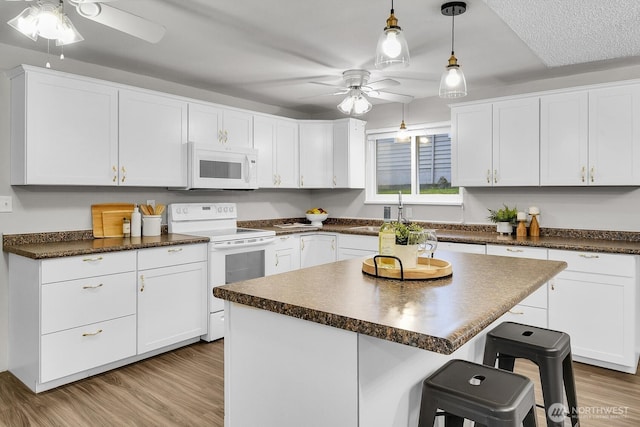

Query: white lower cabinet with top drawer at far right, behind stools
(549, 249), (638, 373)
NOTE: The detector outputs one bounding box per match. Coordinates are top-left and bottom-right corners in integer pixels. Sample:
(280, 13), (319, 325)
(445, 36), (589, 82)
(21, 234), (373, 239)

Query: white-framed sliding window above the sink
(366, 125), (462, 204)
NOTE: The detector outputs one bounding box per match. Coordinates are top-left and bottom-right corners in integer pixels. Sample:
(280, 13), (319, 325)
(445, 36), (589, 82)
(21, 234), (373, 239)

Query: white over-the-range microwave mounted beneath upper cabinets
(182, 142), (258, 190)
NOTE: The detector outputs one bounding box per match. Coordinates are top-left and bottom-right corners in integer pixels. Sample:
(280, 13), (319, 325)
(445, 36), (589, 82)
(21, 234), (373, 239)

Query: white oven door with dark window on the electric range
(209, 236), (275, 313)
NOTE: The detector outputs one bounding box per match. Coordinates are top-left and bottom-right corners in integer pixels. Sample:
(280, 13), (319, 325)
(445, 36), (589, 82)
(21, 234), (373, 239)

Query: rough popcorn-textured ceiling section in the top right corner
(485, 0), (640, 67)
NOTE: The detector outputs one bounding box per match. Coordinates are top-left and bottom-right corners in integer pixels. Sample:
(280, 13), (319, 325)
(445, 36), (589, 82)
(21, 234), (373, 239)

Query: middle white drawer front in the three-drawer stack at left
(41, 271), (136, 334)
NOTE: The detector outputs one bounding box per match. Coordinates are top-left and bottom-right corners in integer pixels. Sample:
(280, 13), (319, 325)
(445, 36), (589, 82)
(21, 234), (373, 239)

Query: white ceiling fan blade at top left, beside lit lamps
(76, 3), (167, 43)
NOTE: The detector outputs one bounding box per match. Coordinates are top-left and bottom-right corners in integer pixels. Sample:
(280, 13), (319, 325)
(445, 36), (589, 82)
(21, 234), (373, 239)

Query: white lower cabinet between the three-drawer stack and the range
(138, 245), (207, 354)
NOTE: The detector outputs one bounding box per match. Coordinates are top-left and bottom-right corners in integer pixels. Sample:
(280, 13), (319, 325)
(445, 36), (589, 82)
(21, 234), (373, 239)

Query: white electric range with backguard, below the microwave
(167, 203), (276, 341)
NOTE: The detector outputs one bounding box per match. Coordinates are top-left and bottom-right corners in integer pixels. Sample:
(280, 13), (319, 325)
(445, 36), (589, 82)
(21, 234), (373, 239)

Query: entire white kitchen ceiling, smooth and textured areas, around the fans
(0, 0), (640, 116)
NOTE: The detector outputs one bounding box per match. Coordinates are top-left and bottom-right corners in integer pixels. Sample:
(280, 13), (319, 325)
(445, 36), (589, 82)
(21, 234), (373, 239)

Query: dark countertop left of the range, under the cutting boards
(2, 234), (209, 259)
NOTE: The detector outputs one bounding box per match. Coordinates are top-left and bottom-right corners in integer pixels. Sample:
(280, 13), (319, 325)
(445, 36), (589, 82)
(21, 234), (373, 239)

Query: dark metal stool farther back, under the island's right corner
(483, 322), (580, 427)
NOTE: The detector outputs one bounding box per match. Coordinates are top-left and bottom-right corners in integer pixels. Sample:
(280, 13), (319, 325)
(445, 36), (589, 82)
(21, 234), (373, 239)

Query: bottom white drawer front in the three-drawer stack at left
(40, 315), (136, 383)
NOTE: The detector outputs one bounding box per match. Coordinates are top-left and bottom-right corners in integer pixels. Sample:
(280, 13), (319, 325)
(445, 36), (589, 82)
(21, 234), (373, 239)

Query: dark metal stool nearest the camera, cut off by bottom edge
(418, 359), (537, 427)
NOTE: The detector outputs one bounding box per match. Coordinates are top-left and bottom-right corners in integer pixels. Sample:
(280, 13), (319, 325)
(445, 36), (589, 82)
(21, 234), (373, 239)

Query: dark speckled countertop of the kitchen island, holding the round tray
(213, 251), (566, 354)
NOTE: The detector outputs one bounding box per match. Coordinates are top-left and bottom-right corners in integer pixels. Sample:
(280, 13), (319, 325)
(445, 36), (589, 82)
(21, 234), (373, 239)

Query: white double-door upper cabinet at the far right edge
(540, 85), (640, 186)
